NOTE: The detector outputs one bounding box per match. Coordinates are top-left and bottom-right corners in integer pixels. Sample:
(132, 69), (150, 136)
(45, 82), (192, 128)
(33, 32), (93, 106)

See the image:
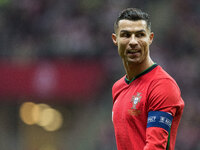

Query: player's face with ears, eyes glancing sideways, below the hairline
(112, 20), (153, 64)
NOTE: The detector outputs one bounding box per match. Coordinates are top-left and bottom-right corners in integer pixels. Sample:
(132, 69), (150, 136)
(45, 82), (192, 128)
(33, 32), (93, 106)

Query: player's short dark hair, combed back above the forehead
(114, 8), (151, 33)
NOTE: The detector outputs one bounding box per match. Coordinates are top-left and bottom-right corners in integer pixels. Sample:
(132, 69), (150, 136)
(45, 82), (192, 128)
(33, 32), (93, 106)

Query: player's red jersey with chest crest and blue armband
(112, 64), (184, 150)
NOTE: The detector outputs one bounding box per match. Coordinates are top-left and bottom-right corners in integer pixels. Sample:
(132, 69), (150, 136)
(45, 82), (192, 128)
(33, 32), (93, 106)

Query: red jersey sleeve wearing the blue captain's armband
(144, 79), (181, 150)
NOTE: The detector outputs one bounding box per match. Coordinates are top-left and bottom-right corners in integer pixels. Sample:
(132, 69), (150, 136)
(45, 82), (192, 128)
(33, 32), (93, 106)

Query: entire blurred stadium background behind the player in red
(0, 0), (200, 150)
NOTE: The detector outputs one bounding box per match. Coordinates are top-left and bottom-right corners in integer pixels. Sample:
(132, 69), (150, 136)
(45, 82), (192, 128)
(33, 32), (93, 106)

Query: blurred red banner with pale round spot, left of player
(0, 61), (105, 100)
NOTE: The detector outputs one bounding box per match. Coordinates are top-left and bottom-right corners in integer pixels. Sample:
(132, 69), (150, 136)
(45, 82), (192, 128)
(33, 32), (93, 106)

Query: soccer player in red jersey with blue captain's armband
(112, 8), (184, 150)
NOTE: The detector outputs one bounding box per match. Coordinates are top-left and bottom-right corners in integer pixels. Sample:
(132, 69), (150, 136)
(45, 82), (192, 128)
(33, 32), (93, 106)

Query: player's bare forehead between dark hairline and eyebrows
(118, 20), (147, 32)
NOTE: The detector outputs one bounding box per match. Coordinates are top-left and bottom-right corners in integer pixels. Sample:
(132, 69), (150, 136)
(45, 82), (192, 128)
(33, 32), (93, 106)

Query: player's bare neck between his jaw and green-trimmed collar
(123, 58), (154, 80)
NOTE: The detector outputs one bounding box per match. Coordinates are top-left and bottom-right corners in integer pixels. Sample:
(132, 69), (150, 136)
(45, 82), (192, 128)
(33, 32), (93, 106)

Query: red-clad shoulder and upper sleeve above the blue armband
(148, 74), (184, 116)
